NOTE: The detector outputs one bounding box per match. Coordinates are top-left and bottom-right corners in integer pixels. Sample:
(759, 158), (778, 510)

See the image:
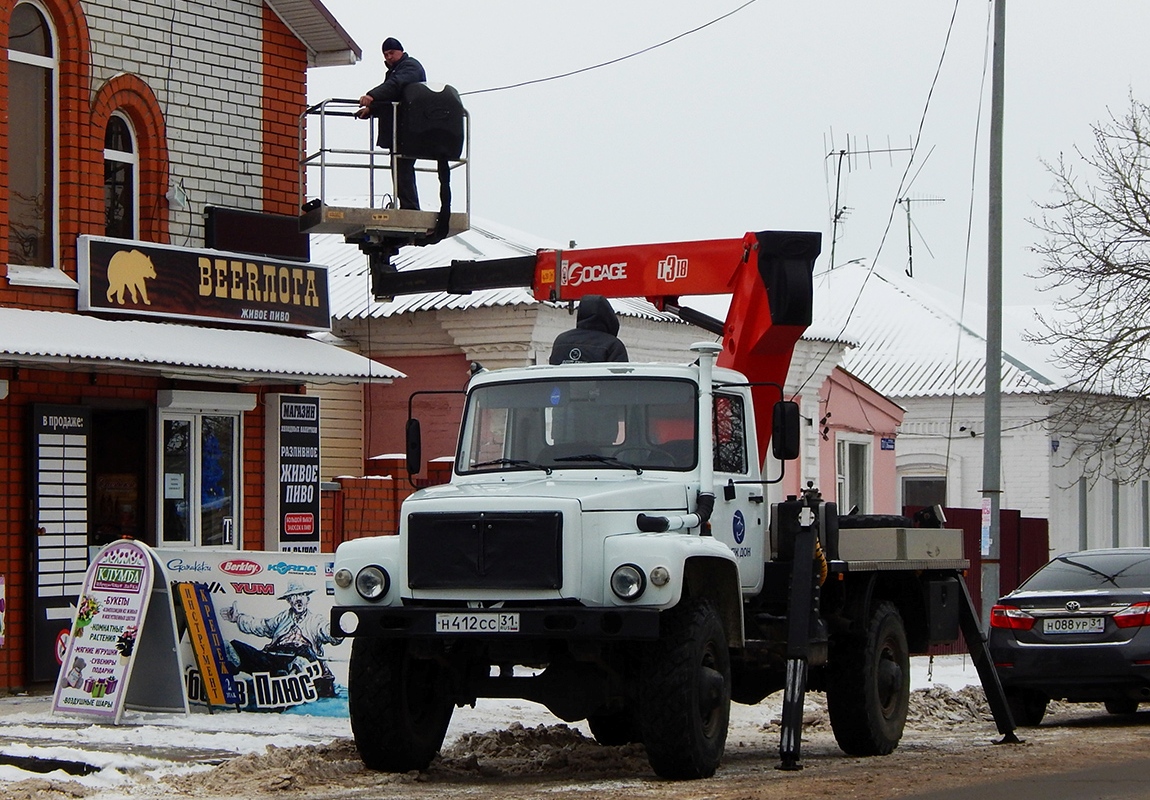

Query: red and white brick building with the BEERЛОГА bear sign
(0, 0), (399, 691)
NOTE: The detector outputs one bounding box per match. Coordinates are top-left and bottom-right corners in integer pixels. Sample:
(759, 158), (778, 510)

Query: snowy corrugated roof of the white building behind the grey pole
(814, 264), (1059, 398)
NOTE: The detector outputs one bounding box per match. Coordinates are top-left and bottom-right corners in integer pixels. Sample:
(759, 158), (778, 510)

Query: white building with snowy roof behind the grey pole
(815, 264), (1150, 553)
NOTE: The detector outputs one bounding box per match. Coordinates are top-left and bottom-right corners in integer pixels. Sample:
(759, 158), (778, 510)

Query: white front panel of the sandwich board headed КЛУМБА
(52, 539), (155, 722)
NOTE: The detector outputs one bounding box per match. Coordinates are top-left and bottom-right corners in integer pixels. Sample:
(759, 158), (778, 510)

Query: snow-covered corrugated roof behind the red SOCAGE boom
(312, 216), (682, 323)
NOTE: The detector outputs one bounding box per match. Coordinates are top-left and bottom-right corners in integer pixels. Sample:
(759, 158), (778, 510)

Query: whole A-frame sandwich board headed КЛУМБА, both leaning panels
(52, 539), (187, 724)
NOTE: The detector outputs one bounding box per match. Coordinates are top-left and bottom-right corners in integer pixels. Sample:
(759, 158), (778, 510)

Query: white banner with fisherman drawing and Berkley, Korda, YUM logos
(159, 549), (351, 716)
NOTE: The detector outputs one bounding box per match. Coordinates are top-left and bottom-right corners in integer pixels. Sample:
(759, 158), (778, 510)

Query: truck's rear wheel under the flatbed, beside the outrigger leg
(827, 602), (911, 755)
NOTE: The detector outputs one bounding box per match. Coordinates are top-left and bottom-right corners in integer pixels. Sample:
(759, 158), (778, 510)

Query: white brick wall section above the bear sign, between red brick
(83, 0), (263, 246)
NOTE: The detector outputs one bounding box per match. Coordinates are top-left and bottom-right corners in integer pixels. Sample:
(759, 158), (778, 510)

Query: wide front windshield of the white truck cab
(455, 376), (698, 474)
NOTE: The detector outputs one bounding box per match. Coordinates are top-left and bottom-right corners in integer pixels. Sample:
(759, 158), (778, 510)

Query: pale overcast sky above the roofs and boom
(308, 0), (1150, 303)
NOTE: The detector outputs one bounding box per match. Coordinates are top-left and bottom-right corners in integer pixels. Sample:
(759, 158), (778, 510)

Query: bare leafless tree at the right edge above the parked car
(1032, 98), (1150, 478)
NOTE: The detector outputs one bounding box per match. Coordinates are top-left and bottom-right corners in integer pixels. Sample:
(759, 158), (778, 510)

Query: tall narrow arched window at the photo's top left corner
(8, 2), (56, 267)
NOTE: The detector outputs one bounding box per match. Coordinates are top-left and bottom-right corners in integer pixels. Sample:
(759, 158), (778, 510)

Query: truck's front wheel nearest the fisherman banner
(347, 637), (453, 772)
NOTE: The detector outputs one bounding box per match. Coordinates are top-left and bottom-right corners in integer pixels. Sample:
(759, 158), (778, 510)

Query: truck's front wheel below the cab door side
(639, 600), (730, 780)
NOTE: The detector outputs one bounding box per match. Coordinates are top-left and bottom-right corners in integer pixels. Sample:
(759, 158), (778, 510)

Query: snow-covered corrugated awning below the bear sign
(0, 308), (404, 383)
